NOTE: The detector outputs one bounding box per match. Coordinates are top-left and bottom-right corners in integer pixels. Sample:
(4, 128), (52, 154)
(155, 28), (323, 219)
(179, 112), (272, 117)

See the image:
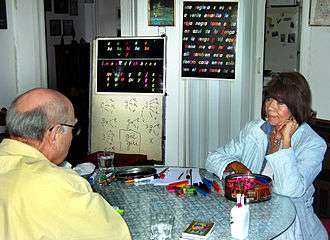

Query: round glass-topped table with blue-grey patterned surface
(92, 167), (296, 240)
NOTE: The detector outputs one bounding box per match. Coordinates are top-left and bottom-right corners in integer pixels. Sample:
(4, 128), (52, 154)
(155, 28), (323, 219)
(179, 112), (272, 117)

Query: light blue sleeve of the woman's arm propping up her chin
(265, 129), (326, 197)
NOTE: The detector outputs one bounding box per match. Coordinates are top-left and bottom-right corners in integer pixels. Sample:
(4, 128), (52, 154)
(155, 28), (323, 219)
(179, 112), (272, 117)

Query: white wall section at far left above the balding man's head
(0, 0), (47, 107)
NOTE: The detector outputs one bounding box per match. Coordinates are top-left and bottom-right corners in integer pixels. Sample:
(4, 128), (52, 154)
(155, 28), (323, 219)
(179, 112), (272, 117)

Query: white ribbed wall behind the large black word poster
(121, 0), (265, 166)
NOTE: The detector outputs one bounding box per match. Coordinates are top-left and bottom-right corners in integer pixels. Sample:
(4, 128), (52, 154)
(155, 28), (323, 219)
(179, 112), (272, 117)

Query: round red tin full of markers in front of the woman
(225, 174), (272, 202)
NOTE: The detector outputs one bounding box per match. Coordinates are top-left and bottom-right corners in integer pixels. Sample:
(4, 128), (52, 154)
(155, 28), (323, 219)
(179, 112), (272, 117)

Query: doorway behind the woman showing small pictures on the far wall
(263, 0), (301, 86)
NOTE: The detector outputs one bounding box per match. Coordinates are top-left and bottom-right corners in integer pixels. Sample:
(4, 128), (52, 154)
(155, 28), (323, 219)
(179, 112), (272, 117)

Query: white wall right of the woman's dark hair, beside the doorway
(300, 0), (330, 120)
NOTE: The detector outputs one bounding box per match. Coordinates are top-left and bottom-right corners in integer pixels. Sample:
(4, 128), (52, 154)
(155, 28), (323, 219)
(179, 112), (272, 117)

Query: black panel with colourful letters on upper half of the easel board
(96, 37), (165, 93)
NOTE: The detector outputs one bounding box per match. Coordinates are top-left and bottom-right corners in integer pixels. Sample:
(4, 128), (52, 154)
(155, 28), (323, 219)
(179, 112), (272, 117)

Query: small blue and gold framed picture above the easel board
(148, 0), (175, 26)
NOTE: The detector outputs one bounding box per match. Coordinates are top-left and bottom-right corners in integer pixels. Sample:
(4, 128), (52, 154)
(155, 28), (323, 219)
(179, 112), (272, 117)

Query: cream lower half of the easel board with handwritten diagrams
(91, 94), (163, 161)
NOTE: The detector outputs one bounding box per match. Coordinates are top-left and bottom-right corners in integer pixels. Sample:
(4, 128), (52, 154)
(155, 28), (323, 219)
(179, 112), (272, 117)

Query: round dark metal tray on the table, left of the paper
(115, 167), (157, 179)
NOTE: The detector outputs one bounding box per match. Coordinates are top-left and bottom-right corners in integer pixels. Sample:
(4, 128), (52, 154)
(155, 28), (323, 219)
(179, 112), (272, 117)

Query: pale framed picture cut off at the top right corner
(309, 0), (330, 26)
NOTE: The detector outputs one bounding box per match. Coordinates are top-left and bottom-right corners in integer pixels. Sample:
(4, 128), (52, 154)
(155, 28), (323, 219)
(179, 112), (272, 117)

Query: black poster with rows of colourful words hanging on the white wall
(181, 1), (238, 79)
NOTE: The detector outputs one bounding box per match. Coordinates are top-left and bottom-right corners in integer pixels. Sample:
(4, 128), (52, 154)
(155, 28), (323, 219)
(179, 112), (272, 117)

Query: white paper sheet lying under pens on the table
(153, 167), (202, 186)
